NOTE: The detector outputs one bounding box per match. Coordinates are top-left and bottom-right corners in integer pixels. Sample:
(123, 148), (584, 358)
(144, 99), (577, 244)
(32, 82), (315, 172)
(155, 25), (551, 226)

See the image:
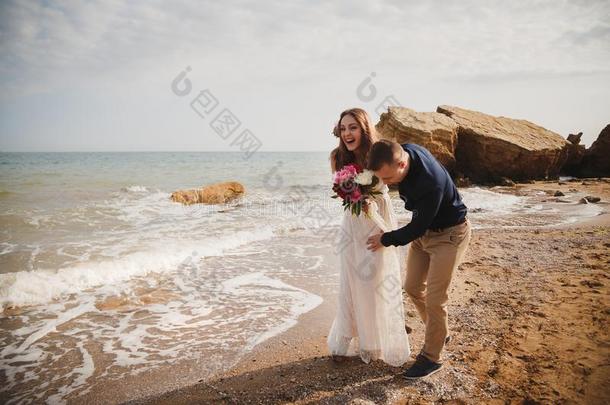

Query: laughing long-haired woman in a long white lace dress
(327, 108), (410, 367)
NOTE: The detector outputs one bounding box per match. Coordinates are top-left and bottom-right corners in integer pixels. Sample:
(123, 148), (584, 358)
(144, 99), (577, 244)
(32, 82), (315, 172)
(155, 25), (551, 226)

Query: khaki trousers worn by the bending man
(404, 219), (472, 362)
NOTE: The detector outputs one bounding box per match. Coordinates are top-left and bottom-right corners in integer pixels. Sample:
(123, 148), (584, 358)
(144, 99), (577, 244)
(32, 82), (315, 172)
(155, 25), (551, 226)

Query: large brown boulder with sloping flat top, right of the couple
(436, 105), (569, 182)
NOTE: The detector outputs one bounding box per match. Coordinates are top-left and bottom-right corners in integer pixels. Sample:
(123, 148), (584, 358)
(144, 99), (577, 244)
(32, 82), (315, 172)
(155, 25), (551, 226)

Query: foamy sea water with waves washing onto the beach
(0, 152), (600, 403)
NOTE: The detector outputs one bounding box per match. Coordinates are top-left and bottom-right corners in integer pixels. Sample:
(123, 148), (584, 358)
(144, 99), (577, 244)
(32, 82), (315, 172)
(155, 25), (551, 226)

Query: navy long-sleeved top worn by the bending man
(381, 143), (468, 246)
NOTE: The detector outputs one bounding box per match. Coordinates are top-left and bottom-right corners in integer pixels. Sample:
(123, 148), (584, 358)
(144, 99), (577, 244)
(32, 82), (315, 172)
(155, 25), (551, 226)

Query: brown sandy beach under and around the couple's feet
(130, 179), (610, 404)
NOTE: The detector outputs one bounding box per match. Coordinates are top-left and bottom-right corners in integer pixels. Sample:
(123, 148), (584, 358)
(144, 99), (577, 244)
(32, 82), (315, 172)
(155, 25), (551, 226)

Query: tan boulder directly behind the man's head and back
(375, 107), (458, 171)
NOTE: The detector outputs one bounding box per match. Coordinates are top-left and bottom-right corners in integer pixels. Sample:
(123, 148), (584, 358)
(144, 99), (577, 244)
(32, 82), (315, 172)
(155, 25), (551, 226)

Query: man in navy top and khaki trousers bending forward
(367, 139), (471, 379)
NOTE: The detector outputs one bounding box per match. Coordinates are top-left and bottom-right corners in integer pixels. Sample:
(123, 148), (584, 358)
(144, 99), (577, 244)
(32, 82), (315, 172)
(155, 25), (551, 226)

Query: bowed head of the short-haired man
(367, 139), (409, 184)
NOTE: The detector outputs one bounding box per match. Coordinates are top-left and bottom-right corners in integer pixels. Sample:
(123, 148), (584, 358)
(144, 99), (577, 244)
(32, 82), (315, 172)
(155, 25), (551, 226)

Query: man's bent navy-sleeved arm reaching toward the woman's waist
(381, 186), (443, 247)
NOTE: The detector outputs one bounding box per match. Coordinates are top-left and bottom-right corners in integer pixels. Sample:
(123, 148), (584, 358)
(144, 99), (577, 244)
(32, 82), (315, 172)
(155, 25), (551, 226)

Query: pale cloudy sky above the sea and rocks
(0, 0), (610, 151)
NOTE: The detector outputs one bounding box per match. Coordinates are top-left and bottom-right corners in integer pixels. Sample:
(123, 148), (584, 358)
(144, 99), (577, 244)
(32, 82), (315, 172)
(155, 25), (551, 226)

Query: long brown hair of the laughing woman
(330, 108), (379, 170)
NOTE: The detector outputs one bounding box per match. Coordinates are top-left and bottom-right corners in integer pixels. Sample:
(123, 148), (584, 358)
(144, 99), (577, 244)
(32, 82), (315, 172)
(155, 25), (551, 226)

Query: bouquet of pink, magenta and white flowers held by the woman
(332, 163), (381, 216)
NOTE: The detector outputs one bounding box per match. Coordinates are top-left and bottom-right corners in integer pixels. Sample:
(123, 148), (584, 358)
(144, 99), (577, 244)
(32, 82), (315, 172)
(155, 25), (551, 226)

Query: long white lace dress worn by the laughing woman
(327, 183), (411, 367)
